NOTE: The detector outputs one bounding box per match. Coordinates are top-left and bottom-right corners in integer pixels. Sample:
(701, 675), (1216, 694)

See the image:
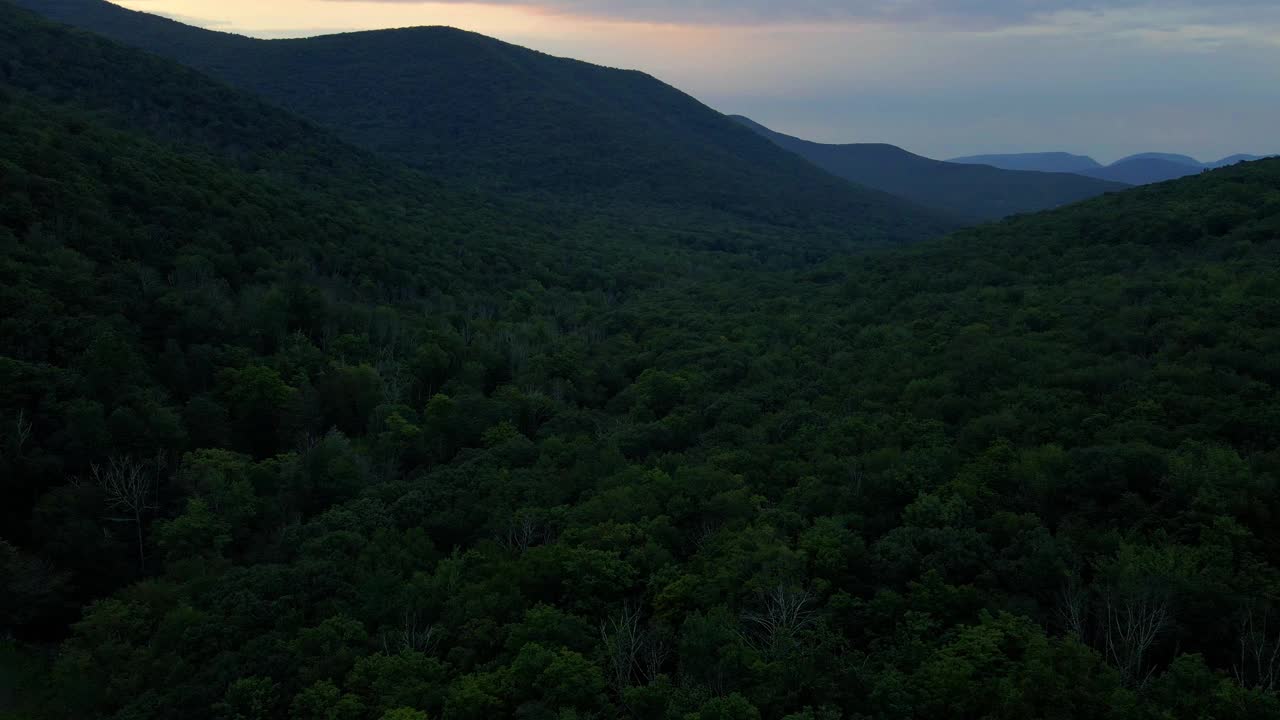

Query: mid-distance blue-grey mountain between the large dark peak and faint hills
(733, 117), (1126, 220)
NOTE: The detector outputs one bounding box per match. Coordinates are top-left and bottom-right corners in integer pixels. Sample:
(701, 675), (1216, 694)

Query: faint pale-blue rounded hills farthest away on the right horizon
(950, 152), (1266, 184)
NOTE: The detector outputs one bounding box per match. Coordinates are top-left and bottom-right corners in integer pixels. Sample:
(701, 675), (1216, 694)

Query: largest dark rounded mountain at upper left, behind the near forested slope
(10, 0), (955, 245)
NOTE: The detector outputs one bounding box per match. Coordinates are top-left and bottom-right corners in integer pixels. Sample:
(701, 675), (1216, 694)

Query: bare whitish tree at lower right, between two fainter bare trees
(1102, 579), (1172, 687)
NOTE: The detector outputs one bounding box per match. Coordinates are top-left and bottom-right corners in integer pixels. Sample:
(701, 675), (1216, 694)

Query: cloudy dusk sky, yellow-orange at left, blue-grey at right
(115, 0), (1280, 163)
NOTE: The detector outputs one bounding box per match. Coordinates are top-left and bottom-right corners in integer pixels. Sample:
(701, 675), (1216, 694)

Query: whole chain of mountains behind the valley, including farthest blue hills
(18, 0), (1264, 226)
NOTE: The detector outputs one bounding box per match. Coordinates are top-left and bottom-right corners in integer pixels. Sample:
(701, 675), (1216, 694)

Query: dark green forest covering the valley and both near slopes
(0, 3), (1280, 720)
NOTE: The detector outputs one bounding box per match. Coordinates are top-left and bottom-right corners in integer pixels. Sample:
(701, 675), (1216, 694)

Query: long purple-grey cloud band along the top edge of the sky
(317, 0), (1277, 29)
